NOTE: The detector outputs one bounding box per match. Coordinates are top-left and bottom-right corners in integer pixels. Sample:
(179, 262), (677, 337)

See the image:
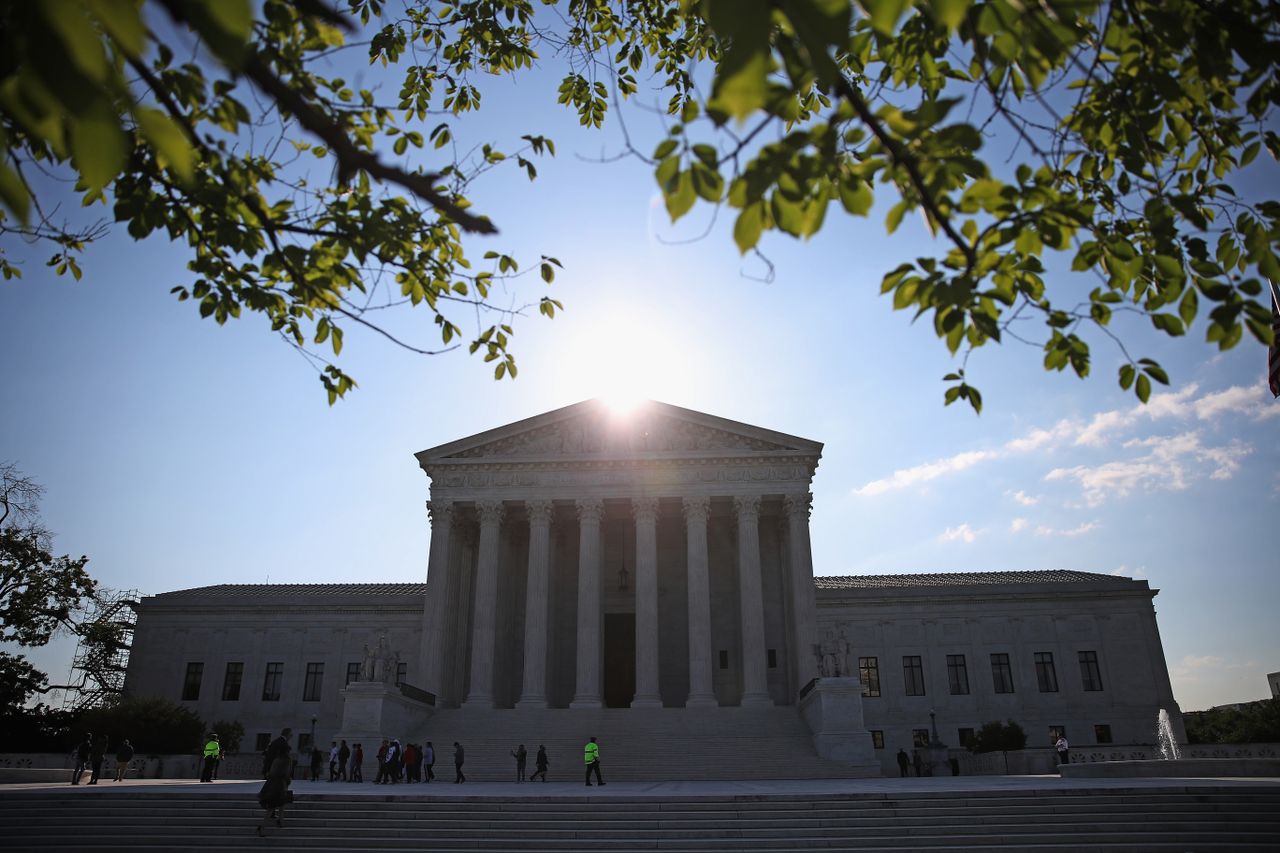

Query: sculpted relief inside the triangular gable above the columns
(457, 418), (790, 459)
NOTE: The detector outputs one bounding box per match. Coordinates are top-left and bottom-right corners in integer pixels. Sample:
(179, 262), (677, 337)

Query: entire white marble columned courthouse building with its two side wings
(125, 401), (1180, 774)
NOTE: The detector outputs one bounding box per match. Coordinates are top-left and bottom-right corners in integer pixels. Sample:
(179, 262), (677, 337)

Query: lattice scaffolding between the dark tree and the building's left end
(63, 588), (141, 711)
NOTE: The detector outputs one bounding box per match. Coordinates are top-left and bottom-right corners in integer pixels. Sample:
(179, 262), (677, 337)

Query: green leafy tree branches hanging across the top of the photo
(0, 0), (1280, 409)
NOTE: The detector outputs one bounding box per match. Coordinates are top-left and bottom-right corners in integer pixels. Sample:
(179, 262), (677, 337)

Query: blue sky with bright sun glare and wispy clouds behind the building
(0, 21), (1280, 710)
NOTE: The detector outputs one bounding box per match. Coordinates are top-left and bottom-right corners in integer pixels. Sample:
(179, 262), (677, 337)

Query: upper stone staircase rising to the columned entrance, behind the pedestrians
(409, 707), (881, 783)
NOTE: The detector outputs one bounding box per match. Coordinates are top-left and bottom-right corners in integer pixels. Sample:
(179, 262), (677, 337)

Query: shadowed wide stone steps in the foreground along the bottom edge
(0, 784), (1280, 853)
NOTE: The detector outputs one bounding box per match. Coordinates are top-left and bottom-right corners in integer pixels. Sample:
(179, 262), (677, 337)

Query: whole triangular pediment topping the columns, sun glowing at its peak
(417, 400), (822, 464)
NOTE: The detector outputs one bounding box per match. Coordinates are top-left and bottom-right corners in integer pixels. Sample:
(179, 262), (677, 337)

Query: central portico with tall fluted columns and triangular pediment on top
(415, 401), (822, 708)
